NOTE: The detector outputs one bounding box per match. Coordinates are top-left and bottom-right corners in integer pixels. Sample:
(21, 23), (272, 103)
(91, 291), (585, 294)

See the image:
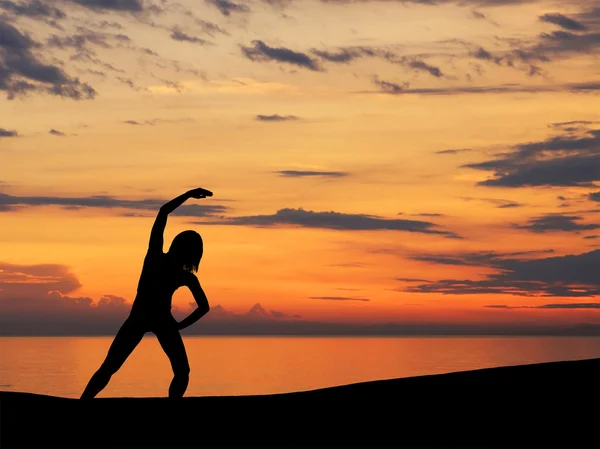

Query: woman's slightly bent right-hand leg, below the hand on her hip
(154, 319), (190, 398)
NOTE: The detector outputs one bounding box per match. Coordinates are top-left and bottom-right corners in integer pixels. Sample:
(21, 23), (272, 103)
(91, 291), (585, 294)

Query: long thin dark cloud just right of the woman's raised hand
(197, 209), (458, 238)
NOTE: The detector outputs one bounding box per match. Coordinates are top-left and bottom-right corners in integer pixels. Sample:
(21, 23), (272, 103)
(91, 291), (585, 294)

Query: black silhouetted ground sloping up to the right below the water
(0, 359), (600, 449)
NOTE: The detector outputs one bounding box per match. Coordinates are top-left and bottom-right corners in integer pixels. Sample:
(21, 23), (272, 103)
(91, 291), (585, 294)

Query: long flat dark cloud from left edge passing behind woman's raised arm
(0, 193), (227, 217)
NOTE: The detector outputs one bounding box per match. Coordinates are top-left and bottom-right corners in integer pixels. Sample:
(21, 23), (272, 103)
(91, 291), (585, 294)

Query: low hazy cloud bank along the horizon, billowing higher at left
(0, 262), (600, 336)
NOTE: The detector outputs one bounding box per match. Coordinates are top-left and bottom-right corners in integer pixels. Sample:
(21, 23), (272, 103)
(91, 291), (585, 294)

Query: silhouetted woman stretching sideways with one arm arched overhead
(81, 188), (212, 399)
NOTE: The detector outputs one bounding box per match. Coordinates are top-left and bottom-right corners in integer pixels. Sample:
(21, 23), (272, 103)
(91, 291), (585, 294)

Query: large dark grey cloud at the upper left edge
(0, 17), (96, 100)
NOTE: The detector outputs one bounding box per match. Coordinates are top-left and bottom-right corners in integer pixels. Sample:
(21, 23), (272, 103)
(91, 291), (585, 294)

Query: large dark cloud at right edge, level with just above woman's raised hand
(463, 130), (600, 187)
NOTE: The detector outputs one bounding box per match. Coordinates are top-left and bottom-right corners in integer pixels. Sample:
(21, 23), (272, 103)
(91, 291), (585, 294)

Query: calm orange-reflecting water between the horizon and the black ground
(0, 335), (600, 398)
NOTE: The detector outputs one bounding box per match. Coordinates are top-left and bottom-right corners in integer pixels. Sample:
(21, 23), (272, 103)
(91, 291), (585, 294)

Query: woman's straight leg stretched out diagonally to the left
(81, 317), (146, 399)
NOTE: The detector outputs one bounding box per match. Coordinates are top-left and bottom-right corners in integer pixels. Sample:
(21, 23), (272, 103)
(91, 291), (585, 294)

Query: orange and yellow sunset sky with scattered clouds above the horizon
(0, 0), (600, 334)
